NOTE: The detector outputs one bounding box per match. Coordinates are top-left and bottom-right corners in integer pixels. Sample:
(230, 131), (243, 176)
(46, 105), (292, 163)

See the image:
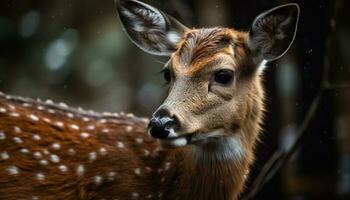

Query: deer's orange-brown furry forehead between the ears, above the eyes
(170, 28), (244, 74)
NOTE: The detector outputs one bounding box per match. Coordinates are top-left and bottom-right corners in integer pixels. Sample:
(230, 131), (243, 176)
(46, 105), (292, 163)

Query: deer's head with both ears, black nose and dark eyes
(117, 0), (299, 147)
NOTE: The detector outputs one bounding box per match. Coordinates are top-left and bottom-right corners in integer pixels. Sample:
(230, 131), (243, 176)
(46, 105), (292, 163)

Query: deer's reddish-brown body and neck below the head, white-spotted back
(0, 83), (260, 200)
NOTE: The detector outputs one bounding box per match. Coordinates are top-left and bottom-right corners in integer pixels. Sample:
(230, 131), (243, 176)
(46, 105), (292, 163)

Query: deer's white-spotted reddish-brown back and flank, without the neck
(0, 94), (161, 199)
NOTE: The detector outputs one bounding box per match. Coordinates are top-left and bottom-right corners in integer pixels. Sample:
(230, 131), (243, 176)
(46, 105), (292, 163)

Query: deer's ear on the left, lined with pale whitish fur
(116, 0), (187, 56)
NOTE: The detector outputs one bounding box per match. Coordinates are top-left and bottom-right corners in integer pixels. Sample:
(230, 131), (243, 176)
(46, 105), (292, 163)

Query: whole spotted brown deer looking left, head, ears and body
(0, 0), (299, 200)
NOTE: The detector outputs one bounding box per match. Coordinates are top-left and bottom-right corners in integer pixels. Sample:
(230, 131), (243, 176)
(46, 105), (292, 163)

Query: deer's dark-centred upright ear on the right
(248, 3), (299, 62)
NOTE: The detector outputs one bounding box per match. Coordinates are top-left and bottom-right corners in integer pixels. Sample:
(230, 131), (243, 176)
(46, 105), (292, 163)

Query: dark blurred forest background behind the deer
(0, 0), (350, 200)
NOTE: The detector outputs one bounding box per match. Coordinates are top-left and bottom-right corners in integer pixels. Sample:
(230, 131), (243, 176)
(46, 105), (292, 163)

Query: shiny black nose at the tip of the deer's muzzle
(148, 110), (175, 139)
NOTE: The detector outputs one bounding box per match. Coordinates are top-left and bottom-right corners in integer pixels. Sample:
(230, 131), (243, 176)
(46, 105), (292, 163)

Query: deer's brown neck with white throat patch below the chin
(164, 134), (249, 200)
